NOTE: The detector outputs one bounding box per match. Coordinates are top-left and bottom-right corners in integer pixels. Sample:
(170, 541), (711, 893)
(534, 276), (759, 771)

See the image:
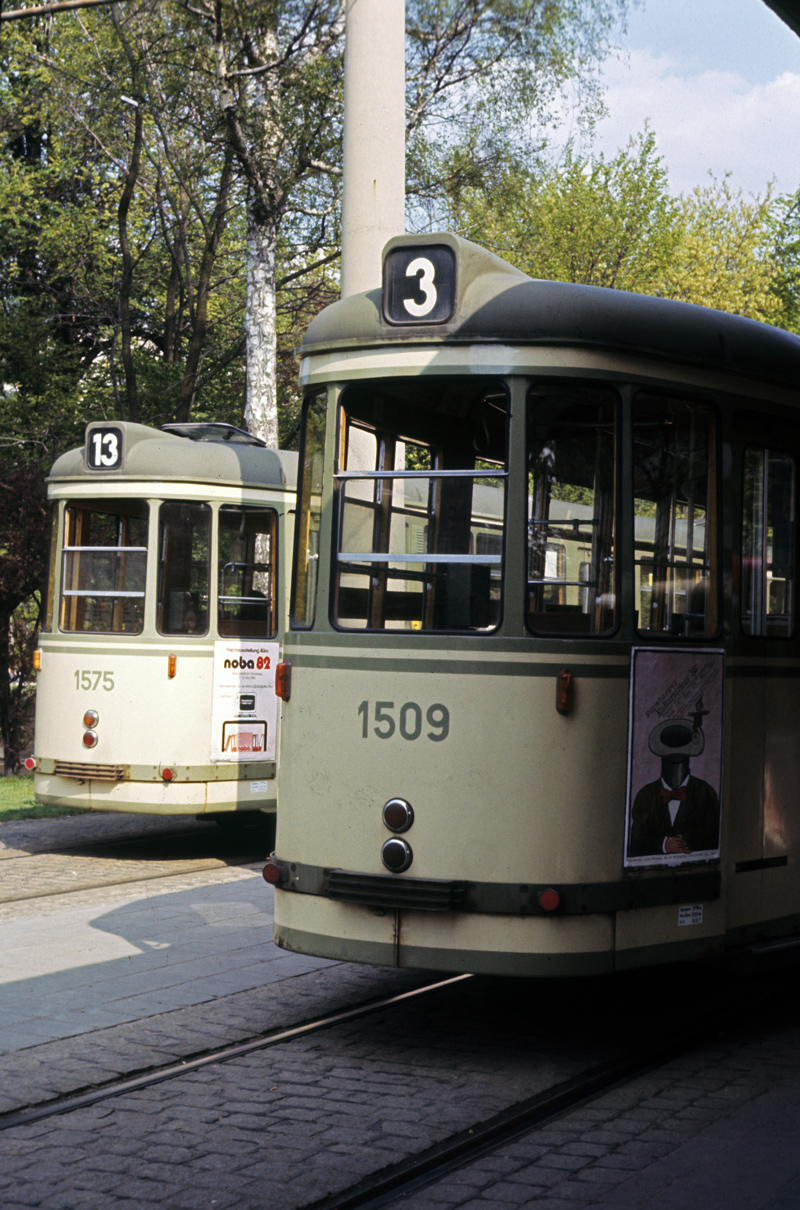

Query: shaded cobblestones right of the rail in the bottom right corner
(391, 1009), (800, 1210)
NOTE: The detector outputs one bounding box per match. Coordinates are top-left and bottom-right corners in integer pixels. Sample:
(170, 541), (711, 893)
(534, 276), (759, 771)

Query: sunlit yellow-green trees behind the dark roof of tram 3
(442, 131), (800, 327)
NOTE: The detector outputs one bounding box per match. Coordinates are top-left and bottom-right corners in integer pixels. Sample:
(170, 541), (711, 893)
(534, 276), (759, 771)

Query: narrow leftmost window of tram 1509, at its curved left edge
(290, 392), (327, 628)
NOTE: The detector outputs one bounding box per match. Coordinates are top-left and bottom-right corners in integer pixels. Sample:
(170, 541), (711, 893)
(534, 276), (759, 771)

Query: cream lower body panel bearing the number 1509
(278, 649), (627, 882)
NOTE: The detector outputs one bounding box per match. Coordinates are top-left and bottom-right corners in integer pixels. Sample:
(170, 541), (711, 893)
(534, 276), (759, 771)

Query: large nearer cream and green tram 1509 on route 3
(264, 235), (800, 976)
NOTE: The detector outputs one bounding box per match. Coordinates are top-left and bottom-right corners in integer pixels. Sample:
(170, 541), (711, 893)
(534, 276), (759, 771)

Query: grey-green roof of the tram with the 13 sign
(47, 420), (298, 490)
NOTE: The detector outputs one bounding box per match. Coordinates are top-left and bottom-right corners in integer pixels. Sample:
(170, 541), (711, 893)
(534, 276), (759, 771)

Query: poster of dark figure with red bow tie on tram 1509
(625, 649), (725, 869)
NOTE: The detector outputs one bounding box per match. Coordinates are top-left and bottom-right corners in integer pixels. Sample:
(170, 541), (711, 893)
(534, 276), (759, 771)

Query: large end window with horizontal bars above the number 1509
(333, 379), (508, 632)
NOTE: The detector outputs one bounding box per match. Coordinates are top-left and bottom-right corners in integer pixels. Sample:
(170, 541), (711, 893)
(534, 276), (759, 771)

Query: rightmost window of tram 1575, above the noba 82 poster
(217, 505), (277, 639)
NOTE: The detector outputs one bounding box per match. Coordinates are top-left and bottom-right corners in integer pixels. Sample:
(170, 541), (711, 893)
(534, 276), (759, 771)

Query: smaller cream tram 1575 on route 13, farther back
(30, 421), (297, 830)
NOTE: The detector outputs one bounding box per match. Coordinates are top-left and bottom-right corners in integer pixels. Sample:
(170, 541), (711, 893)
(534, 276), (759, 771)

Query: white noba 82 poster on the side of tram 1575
(211, 639), (280, 761)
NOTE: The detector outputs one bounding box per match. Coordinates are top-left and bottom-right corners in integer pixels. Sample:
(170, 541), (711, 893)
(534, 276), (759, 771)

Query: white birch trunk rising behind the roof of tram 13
(244, 206), (278, 449)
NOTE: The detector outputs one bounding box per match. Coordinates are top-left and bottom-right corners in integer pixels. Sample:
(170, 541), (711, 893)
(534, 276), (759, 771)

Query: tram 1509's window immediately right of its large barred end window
(528, 385), (618, 635)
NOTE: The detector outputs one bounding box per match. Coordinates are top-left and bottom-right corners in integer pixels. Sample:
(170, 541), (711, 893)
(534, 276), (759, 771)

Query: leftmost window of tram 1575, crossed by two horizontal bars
(59, 500), (148, 634)
